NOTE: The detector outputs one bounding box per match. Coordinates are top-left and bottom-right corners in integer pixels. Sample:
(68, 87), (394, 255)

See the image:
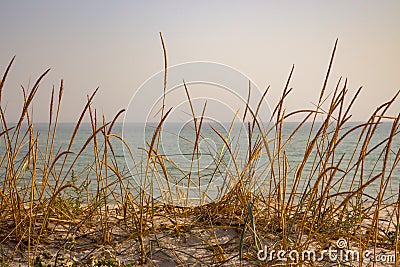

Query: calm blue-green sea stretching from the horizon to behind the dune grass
(0, 121), (400, 205)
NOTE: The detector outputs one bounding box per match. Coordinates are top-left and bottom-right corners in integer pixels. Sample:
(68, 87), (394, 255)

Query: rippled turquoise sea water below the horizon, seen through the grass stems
(0, 121), (400, 205)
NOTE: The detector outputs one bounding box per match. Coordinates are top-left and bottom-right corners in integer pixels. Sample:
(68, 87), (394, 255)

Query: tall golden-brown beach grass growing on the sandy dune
(0, 38), (400, 266)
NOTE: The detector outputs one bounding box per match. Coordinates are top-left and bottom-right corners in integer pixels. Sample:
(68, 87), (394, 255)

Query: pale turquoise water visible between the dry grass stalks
(0, 122), (400, 204)
